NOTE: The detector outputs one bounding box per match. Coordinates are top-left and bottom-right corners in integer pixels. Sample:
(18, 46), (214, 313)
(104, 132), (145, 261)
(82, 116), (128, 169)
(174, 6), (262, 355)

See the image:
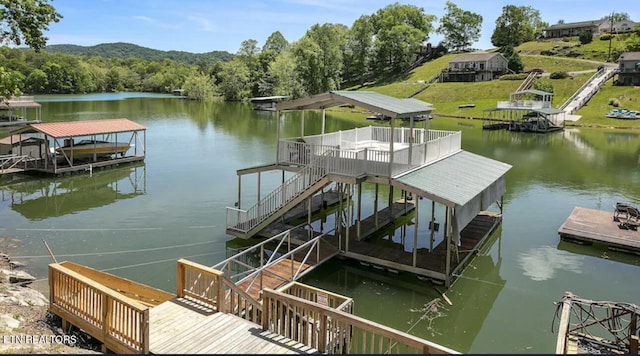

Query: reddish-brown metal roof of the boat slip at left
(11, 119), (147, 138)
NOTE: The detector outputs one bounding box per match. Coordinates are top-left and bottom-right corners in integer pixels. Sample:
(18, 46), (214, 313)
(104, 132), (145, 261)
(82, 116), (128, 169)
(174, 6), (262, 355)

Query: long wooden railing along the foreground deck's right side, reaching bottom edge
(262, 289), (457, 354)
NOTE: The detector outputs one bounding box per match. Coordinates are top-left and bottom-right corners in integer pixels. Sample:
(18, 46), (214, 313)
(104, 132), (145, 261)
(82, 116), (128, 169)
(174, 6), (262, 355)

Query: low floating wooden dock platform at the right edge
(558, 206), (640, 254)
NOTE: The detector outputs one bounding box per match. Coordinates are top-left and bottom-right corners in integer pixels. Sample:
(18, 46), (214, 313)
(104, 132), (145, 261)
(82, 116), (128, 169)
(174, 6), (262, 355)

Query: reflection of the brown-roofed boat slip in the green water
(0, 164), (146, 220)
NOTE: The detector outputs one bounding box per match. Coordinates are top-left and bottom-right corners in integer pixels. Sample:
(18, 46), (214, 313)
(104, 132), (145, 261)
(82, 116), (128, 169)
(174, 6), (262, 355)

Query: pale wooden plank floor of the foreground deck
(149, 298), (318, 354)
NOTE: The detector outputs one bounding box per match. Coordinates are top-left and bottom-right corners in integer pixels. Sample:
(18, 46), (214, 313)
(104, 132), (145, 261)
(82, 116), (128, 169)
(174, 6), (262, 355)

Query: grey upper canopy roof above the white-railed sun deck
(276, 90), (433, 118)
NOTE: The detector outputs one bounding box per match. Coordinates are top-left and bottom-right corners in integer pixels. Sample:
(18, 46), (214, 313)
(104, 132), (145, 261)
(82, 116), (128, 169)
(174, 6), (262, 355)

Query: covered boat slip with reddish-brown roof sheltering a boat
(11, 119), (147, 174)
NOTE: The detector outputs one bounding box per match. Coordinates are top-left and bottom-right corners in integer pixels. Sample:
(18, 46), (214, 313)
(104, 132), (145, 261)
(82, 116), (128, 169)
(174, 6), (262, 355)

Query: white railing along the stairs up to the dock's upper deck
(227, 150), (332, 232)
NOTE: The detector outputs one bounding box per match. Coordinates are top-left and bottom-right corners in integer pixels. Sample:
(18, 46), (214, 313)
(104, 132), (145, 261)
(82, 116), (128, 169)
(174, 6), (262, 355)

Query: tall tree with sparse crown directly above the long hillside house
(437, 1), (482, 51)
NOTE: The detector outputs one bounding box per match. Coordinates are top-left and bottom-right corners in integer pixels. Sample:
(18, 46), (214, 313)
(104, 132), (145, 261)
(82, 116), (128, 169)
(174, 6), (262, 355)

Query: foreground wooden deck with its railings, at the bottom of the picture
(49, 260), (457, 354)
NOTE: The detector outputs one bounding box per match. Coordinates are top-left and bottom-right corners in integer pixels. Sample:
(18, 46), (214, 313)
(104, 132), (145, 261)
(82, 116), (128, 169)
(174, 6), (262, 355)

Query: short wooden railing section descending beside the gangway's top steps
(176, 259), (262, 324)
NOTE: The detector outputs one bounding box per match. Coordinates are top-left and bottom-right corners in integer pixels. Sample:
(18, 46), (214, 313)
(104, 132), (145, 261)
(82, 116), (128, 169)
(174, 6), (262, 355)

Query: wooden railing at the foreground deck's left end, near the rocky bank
(49, 263), (149, 353)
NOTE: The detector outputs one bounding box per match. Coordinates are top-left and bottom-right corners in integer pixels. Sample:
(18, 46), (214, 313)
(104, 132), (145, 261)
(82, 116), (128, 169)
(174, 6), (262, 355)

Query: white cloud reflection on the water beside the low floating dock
(518, 246), (584, 281)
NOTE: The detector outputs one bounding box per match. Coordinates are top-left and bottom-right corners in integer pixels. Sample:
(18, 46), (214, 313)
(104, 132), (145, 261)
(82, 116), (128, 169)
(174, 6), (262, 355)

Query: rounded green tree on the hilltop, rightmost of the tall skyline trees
(491, 5), (547, 47)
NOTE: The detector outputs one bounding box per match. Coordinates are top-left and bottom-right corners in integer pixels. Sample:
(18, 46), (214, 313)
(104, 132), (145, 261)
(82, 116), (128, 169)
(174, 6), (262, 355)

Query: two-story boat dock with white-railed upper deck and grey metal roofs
(227, 91), (511, 286)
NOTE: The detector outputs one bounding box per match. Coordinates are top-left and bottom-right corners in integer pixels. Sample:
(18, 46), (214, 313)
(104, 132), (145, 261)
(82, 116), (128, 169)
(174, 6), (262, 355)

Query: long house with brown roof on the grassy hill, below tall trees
(440, 52), (509, 83)
